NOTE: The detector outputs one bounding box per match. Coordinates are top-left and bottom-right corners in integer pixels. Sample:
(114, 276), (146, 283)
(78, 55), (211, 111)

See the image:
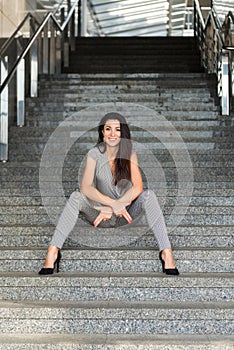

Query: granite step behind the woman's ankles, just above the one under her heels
(0, 248), (233, 274)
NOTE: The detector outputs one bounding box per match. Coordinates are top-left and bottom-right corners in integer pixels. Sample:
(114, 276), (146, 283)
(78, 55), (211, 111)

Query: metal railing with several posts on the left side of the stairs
(0, 0), (81, 162)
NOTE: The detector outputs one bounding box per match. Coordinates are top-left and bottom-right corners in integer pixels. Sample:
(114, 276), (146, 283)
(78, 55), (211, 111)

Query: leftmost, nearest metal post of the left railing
(0, 56), (8, 162)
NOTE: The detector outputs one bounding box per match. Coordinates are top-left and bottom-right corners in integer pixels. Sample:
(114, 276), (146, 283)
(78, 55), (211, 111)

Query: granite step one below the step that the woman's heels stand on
(0, 301), (233, 336)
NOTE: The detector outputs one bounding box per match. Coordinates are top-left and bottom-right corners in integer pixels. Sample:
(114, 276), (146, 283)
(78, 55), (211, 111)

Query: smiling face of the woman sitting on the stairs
(102, 119), (121, 147)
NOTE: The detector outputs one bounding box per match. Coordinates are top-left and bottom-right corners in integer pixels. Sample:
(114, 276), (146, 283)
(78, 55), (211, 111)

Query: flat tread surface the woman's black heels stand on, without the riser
(0, 271), (234, 278)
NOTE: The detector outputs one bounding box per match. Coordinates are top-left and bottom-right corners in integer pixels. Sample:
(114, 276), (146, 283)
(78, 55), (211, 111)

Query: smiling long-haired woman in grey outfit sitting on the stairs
(39, 113), (179, 275)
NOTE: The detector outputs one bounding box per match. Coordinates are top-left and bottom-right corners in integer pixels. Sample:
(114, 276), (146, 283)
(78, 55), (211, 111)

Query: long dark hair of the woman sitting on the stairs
(96, 112), (132, 185)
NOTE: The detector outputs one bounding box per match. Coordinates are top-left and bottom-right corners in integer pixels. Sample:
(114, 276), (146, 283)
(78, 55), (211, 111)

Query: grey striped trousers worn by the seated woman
(50, 190), (171, 251)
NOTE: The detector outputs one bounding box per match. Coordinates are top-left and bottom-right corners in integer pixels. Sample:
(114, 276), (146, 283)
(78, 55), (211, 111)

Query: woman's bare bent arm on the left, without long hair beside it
(80, 156), (115, 206)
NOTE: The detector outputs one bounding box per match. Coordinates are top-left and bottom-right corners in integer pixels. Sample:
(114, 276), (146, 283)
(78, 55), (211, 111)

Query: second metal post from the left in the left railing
(16, 59), (25, 126)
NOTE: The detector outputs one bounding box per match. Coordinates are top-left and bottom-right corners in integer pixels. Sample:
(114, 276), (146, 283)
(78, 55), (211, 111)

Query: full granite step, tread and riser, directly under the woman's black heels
(0, 272), (233, 303)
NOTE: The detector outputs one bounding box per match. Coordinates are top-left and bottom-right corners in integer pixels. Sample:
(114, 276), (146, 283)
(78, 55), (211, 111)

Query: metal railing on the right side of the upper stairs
(194, 0), (234, 115)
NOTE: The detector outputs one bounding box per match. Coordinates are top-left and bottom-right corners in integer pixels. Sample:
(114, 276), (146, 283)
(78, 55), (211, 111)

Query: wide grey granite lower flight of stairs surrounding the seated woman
(0, 37), (234, 350)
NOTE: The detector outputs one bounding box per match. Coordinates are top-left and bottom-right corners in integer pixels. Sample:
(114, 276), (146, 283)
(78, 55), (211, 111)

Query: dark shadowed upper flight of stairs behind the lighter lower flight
(64, 37), (202, 73)
